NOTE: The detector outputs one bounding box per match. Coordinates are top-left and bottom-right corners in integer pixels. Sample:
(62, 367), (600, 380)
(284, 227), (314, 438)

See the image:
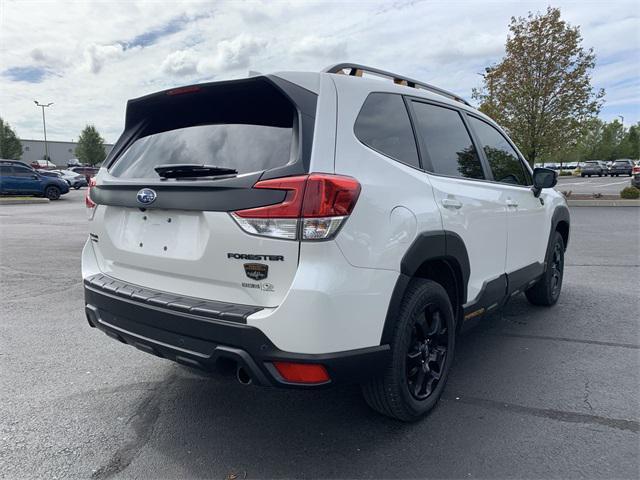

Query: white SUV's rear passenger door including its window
(410, 99), (507, 313)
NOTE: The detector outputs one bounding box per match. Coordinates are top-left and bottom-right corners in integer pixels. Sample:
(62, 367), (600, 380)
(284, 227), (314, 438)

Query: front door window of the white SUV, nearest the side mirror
(469, 117), (531, 185)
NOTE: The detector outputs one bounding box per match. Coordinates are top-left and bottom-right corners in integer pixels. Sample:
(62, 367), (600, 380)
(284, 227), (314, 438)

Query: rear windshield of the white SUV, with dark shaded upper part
(109, 79), (300, 180)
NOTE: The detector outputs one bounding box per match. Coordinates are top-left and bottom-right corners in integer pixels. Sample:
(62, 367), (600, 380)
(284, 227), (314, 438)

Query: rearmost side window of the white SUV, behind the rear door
(353, 93), (420, 168)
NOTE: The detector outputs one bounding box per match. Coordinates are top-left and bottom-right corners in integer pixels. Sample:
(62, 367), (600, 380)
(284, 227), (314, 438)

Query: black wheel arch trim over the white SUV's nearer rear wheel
(380, 230), (471, 344)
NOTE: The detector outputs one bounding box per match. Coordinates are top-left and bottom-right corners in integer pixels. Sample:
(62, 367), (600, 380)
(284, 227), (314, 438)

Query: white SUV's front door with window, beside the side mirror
(468, 115), (550, 292)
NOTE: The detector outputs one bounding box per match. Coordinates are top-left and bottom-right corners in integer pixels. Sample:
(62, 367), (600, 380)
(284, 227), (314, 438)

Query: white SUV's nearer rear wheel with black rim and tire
(362, 279), (455, 422)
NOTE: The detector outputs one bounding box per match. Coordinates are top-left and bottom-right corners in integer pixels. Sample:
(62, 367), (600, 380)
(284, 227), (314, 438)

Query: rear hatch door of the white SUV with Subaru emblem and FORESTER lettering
(90, 77), (316, 307)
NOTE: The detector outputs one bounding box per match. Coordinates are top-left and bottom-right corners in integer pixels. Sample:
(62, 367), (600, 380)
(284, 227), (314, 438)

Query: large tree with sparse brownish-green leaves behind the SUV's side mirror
(473, 7), (604, 165)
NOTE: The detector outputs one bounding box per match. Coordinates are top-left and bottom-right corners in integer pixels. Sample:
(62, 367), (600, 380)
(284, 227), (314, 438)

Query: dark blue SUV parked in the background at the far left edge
(0, 160), (69, 200)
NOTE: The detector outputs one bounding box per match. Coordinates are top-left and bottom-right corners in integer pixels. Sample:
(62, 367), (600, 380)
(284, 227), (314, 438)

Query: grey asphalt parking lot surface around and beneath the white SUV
(0, 191), (640, 479)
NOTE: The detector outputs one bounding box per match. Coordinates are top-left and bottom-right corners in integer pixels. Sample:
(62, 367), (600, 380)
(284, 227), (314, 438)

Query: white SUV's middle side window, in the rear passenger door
(413, 102), (484, 179)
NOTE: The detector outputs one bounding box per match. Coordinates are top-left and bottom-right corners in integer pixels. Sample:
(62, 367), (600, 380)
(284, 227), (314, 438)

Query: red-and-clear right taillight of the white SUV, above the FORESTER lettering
(231, 173), (360, 240)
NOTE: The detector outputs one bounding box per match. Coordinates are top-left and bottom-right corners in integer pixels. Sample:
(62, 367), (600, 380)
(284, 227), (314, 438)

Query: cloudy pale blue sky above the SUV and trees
(0, 0), (640, 142)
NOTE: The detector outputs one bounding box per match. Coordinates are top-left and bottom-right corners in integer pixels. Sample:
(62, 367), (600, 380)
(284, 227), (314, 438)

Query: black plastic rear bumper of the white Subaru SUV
(84, 275), (390, 388)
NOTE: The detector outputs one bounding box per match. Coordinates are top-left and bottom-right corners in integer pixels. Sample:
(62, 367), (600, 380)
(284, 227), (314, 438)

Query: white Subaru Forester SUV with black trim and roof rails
(82, 64), (569, 420)
